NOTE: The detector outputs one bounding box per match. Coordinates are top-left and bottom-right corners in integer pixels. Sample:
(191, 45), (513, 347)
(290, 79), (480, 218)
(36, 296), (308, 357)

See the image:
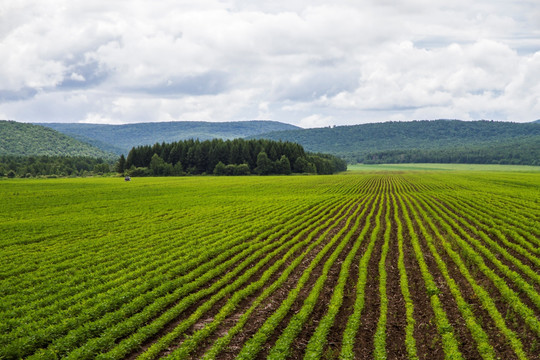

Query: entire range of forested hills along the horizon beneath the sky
(0, 119), (540, 165)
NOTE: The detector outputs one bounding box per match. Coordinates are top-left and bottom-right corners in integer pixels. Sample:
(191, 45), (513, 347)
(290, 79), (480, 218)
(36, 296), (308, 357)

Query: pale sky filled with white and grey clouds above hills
(0, 0), (540, 127)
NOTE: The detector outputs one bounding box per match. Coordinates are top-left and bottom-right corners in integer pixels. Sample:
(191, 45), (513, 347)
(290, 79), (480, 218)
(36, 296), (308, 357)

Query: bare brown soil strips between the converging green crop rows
(119, 176), (539, 360)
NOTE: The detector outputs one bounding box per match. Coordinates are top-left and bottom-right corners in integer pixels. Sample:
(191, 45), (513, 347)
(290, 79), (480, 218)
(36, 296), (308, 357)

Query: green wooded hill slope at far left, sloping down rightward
(0, 120), (115, 159)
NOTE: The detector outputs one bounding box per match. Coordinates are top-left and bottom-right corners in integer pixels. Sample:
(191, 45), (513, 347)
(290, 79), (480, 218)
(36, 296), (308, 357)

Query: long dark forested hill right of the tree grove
(253, 120), (540, 165)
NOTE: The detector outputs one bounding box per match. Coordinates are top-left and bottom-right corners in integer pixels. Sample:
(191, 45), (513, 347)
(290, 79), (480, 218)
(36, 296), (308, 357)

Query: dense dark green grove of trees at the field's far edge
(116, 139), (347, 176)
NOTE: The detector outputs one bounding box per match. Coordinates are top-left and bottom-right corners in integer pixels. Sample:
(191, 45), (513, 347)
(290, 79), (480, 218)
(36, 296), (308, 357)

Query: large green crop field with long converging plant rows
(0, 167), (540, 360)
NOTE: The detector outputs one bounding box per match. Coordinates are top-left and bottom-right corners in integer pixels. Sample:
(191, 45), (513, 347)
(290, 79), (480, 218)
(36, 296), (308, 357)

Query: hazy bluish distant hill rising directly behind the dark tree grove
(38, 121), (300, 154)
